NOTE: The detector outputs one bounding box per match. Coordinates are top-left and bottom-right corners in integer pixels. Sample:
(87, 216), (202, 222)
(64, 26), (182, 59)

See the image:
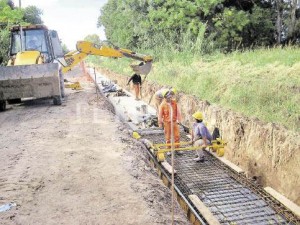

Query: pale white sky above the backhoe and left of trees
(14, 0), (107, 50)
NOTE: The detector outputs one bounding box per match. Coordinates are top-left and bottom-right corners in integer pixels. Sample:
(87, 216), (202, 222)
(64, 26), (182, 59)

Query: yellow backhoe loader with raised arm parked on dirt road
(0, 24), (153, 111)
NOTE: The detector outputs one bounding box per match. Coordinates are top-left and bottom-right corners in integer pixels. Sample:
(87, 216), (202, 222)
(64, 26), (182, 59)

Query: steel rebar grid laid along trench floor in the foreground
(142, 130), (300, 225)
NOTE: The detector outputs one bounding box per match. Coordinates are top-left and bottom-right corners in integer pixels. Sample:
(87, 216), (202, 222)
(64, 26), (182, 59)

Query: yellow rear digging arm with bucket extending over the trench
(62, 41), (153, 75)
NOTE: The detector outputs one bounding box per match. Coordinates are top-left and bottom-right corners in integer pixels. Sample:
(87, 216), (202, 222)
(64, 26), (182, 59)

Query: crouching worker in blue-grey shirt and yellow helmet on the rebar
(192, 111), (212, 162)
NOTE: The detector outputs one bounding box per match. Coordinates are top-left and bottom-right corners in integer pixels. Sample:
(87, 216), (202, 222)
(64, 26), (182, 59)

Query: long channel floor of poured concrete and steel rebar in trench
(89, 69), (300, 225)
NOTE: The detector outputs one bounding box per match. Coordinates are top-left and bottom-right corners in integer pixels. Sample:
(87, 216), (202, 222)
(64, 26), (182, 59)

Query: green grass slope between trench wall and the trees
(86, 47), (300, 132)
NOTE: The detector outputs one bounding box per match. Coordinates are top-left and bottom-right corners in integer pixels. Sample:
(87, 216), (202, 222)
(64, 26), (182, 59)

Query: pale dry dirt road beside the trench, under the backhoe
(0, 67), (189, 225)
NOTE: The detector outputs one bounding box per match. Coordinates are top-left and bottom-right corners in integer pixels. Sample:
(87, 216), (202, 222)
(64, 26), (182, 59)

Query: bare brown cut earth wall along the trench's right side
(98, 68), (300, 205)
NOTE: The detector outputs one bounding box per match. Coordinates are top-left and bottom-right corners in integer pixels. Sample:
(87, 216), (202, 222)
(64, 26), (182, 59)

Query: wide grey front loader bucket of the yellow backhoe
(0, 63), (61, 100)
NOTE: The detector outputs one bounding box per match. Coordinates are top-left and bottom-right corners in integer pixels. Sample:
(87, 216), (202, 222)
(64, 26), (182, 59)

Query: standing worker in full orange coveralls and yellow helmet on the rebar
(158, 90), (181, 153)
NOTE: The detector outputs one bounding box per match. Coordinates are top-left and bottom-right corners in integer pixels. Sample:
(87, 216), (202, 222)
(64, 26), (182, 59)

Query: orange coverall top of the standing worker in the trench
(158, 100), (181, 123)
